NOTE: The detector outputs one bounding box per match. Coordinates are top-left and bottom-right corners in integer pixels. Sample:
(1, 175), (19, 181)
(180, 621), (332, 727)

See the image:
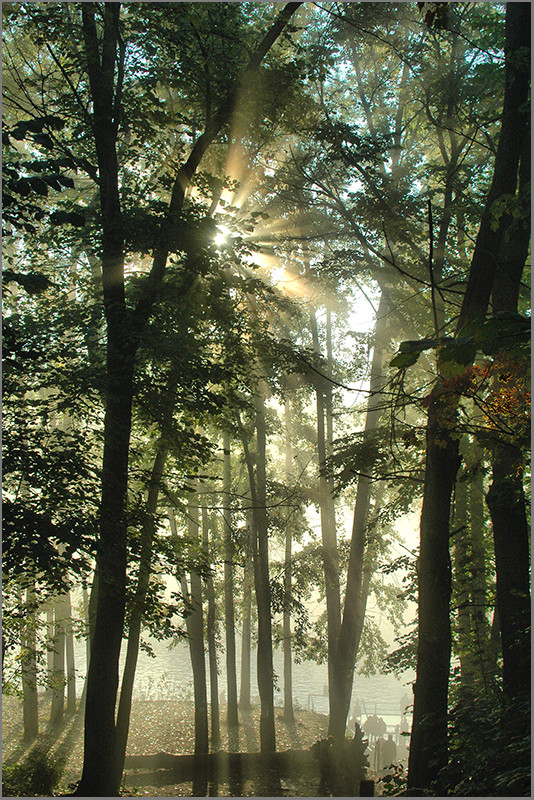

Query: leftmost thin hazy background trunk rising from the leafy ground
(21, 588), (39, 741)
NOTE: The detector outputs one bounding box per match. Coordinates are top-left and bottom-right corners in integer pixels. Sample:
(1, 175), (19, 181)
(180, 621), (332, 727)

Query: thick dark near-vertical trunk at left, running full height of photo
(77, 3), (135, 797)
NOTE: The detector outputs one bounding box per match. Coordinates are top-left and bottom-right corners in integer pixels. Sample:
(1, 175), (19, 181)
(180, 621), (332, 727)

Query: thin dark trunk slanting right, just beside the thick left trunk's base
(116, 441), (168, 783)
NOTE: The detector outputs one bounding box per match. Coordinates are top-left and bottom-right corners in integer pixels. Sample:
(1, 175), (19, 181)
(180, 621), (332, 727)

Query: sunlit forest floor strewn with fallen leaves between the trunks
(2, 696), (364, 797)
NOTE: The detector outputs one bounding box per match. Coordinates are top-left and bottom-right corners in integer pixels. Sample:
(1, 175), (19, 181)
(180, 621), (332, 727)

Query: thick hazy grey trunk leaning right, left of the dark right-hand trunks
(328, 289), (390, 740)
